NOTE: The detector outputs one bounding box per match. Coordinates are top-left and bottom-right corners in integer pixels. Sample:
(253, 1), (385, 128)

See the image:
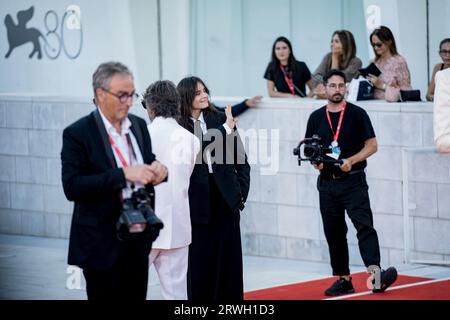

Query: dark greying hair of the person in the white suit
(143, 80), (181, 118)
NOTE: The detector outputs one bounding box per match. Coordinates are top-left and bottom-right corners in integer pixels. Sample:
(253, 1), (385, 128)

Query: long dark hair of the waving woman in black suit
(177, 76), (217, 128)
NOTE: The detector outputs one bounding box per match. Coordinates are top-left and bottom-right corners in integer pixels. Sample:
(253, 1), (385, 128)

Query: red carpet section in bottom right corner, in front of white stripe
(345, 280), (450, 300)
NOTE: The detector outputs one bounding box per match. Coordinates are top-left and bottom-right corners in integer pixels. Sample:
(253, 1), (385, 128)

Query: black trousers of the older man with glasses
(83, 240), (150, 301)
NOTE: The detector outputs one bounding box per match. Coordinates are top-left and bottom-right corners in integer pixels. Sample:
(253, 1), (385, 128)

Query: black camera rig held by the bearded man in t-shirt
(293, 135), (342, 166)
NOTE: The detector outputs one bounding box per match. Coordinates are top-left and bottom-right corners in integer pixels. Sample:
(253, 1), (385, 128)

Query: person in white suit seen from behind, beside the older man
(142, 81), (200, 300)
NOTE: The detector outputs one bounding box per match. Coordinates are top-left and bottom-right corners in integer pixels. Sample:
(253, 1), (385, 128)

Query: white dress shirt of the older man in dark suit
(98, 108), (144, 199)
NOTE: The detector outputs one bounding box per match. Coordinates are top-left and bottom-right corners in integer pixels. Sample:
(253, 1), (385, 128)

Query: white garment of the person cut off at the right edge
(433, 69), (450, 153)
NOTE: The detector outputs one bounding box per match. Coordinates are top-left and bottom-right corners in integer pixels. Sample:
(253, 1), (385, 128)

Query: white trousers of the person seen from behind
(149, 246), (189, 300)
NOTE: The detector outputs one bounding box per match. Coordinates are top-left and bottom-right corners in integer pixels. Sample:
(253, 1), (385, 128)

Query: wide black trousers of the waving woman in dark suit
(188, 176), (244, 302)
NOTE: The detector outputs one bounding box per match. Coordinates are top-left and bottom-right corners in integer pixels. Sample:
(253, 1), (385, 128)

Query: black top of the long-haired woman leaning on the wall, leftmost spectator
(264, 61), (311, 96)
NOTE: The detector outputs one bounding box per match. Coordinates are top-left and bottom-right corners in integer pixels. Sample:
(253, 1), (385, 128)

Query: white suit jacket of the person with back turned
(148, 117), (200, 249)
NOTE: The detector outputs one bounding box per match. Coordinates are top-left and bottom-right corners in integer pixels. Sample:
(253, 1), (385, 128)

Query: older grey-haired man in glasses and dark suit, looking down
(61, 62), (167, 299)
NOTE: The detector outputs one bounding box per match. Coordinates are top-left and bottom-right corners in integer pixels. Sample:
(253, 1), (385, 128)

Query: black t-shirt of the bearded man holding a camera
(305, 102), (375, 175)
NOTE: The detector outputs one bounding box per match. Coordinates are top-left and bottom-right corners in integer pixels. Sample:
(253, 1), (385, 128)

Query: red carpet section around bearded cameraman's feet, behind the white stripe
(244, 272), (430, 300)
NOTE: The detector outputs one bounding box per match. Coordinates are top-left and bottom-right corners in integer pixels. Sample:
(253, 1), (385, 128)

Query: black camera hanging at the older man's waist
(117, 188), (164, 241)
